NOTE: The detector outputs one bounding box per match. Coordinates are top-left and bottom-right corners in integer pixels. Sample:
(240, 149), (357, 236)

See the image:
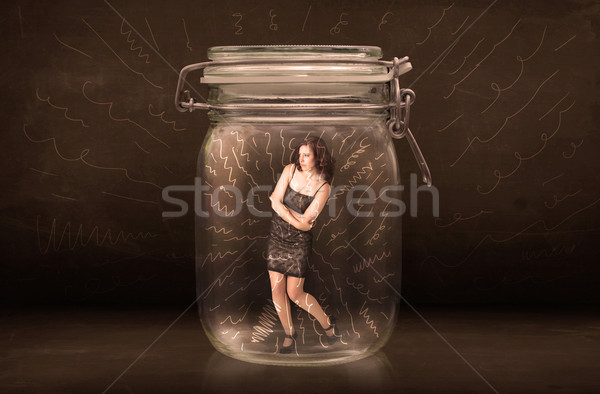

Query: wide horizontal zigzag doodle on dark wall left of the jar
(36, 216), (158, 255)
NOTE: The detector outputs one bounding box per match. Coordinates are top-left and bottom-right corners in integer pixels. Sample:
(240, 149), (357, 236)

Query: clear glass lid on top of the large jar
(201, 45), (412, 84)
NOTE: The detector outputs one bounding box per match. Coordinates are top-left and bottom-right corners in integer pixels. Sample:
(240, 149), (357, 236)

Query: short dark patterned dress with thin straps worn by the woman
(267, 169), (327, 278)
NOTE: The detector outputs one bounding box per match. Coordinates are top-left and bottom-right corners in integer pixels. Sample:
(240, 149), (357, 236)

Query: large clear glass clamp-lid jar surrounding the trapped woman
(175, 46), (430, 365)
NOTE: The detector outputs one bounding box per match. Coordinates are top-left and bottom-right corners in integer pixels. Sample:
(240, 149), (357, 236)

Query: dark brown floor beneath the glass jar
(0, 306), (600, 393)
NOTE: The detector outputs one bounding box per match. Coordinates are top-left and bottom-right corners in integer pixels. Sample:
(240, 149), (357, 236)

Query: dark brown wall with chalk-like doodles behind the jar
(0, 0), (600, 304)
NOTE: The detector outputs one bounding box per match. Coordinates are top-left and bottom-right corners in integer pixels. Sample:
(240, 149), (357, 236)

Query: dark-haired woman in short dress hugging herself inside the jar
(267, 137), (339, 353)
